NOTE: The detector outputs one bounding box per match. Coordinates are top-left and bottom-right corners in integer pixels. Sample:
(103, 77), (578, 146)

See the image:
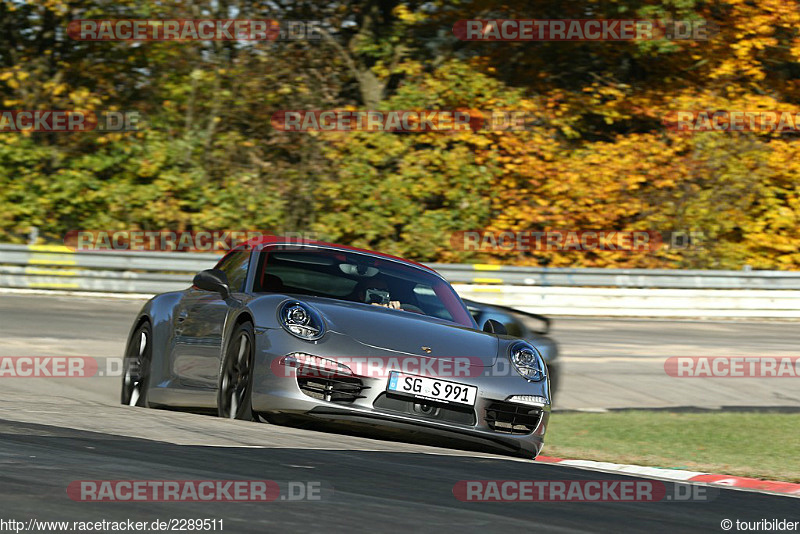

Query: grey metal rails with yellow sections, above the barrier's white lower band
(0, 244), (800, 291)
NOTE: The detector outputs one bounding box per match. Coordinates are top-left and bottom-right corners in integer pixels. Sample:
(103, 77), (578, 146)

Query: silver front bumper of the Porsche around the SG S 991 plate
(252, 330), (550, 458)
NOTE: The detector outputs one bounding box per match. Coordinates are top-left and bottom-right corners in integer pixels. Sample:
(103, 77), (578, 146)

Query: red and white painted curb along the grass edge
(536, 456), (800, 498)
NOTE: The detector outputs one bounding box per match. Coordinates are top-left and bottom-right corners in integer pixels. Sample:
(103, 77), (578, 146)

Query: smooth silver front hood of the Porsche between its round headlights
(299, 297), (498, 366)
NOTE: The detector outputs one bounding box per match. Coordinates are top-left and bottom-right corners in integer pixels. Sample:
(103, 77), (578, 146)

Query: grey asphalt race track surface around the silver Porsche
(0, 294), (800, 532)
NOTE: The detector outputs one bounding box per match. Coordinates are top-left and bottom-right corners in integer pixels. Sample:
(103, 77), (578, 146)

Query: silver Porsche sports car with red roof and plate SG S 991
(121, 236), (550, 457)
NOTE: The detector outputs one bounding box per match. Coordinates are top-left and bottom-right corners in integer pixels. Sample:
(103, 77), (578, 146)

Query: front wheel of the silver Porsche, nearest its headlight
(217, 322), (256, 421)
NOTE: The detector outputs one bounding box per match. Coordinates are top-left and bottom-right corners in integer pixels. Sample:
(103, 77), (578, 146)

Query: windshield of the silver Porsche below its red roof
(253, 246), (475, 327)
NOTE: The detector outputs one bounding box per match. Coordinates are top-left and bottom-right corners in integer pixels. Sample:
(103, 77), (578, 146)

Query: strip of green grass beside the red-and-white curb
(542, 411), (800, 482)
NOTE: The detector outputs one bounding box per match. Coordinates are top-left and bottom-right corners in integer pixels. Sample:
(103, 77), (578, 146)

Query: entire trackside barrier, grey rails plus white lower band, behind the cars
(0, 244), (800, 318)
